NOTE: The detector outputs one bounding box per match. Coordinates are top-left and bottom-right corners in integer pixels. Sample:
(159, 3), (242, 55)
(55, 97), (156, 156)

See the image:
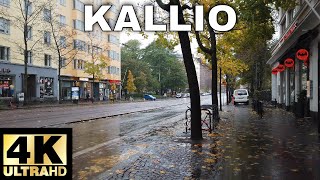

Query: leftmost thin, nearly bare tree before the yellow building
(0, 0), (50, 104)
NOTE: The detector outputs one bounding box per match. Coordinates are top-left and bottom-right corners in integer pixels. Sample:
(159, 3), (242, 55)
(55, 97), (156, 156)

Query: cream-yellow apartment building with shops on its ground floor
(0, 0), (121, 100)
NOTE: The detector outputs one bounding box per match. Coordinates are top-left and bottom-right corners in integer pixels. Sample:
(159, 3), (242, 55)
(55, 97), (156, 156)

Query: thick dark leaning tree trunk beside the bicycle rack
(156, 0), (202, 139)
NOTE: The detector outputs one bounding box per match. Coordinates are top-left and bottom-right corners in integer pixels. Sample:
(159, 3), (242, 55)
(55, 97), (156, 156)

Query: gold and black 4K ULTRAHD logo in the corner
(0, 129), (72, 179)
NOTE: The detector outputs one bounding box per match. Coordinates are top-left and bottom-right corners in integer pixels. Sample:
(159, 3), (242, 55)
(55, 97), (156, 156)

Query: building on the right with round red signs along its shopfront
(268, 0), (320, 124)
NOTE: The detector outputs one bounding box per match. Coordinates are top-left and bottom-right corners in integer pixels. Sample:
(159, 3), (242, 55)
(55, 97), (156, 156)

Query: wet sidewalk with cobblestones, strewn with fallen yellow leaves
(79, 106), (320, 180)
